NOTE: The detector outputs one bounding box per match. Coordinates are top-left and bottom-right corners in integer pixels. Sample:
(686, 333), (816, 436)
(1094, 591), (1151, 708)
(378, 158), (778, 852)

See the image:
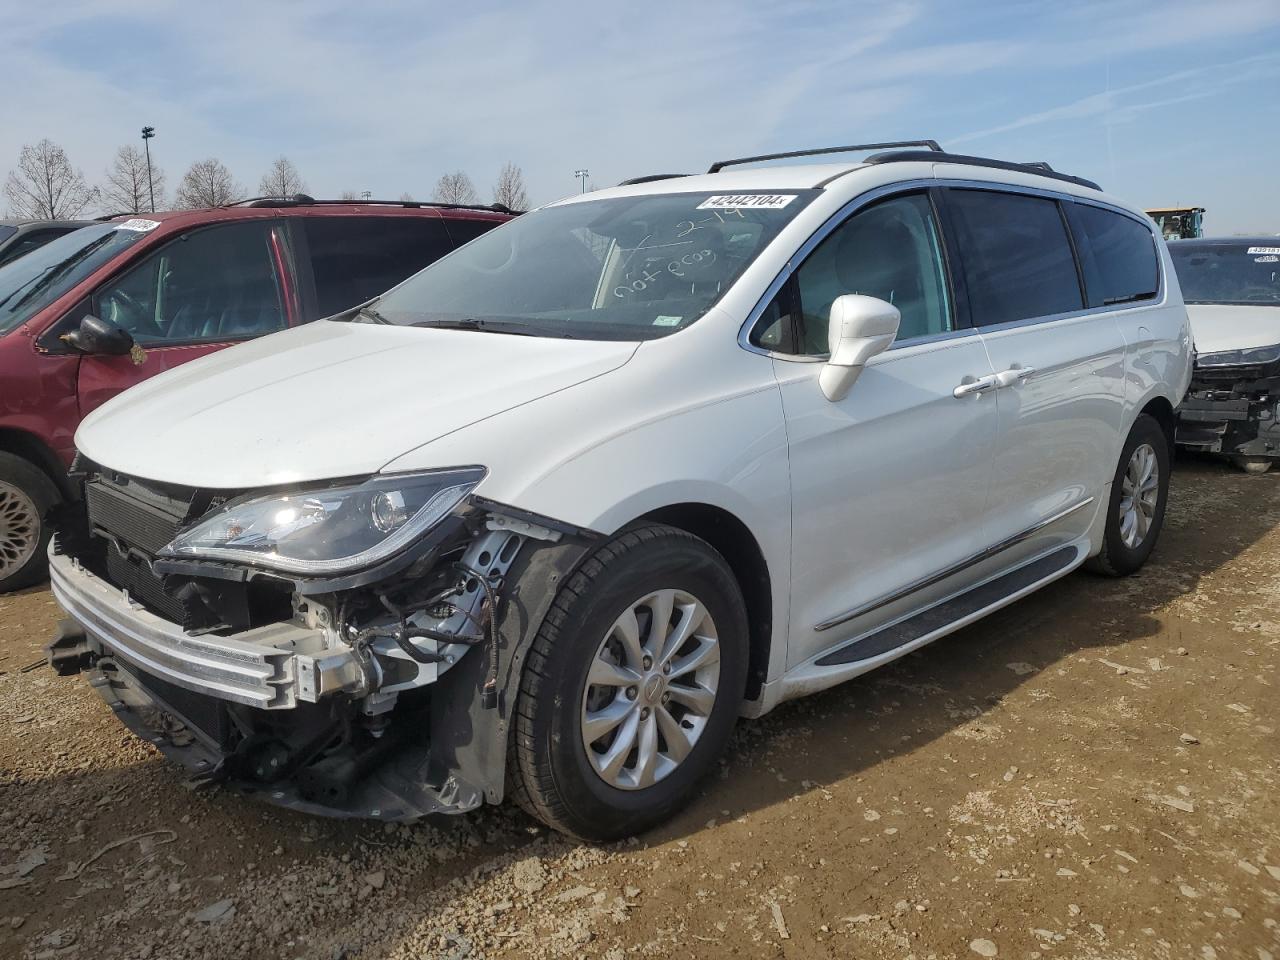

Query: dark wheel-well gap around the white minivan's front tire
(626, 502), (773, 700)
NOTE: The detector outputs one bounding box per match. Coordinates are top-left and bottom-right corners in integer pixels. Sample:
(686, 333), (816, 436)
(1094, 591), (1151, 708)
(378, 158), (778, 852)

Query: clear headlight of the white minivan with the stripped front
(160, 467), (485, 575)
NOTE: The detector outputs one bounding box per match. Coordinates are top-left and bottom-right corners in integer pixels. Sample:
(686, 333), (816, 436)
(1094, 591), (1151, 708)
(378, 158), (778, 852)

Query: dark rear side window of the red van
(303, 216), (453, 316)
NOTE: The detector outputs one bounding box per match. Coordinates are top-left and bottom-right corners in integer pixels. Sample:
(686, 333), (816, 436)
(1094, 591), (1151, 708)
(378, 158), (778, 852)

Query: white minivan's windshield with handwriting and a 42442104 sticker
(369, 189), (817, 340)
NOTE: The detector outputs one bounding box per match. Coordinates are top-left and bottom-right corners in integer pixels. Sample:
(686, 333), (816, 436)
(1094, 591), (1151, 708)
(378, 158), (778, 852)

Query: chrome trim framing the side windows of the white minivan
(737, 179), (1169, 364)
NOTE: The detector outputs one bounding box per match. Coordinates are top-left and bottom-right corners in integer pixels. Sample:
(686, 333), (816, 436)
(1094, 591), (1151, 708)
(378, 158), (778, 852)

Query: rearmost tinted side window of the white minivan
(1066, 204), (1160, 307)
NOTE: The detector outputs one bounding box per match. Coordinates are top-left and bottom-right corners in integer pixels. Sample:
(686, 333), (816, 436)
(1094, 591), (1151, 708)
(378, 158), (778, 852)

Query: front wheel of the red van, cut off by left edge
(0, 453), (61, 594)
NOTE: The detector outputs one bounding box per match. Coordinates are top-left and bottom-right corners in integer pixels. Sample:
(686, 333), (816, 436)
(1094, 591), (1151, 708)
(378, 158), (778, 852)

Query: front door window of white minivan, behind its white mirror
(778, 193), (951, 355)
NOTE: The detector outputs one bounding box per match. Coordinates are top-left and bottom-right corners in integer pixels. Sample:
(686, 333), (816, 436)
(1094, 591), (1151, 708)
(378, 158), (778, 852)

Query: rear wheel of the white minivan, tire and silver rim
(1088, 413), (1169, 577)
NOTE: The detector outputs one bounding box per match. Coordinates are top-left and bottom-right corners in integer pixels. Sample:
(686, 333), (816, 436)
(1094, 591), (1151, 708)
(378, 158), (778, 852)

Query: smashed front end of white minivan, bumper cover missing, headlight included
(47, 462), (594, 820)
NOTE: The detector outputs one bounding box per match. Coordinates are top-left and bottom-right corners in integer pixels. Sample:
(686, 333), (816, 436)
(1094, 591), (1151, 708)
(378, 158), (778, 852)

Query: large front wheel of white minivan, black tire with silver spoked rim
(508, 525), (749, 841)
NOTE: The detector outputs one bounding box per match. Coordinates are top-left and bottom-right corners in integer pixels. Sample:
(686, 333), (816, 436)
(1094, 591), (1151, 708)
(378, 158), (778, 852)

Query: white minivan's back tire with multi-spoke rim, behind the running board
(1085, 413), (1170, 577)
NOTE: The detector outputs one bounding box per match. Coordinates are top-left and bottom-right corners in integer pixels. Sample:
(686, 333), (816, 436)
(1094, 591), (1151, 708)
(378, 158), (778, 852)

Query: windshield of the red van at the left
(0, 220), (159, 334)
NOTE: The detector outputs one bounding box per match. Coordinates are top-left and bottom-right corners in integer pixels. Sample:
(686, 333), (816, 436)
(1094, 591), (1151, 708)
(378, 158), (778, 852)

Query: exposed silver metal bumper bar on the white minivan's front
(49, 554), (366, 710)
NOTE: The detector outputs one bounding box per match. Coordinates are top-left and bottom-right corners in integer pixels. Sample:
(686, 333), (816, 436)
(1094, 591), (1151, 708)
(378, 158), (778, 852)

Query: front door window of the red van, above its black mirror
(93, 221), (287, 343)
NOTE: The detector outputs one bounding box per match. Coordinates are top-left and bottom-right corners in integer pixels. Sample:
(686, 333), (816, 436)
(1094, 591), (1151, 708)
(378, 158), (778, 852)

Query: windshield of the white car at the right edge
(1169, 244), (1280, 306)
